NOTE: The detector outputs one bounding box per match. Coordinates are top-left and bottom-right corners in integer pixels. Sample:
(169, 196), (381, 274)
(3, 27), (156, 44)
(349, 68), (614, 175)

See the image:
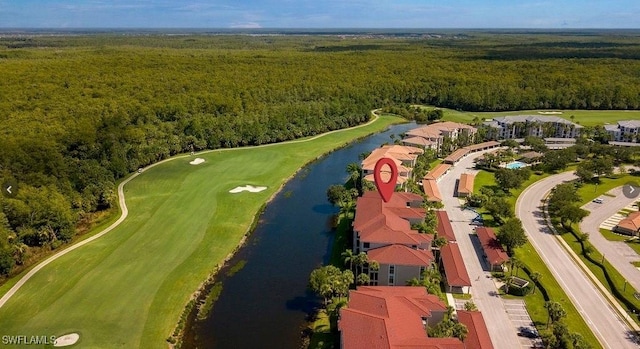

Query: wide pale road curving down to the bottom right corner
(516, 172), (638, 349)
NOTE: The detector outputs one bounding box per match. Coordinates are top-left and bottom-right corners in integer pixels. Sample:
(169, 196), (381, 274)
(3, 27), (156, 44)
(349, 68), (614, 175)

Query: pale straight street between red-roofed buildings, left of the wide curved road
(438, 152), (521, 349)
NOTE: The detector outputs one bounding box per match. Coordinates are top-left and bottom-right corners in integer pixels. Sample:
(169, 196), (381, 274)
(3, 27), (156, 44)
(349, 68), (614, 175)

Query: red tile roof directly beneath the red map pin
(353, 191), (433, 246)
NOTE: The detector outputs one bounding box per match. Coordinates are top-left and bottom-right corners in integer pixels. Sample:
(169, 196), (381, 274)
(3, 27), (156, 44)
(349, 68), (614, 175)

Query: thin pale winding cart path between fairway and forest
(0, 109), (380, 308)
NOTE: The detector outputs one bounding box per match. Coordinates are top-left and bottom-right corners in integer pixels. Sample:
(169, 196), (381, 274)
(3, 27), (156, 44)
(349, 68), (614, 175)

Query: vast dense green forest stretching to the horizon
(0, 32), (640, 277)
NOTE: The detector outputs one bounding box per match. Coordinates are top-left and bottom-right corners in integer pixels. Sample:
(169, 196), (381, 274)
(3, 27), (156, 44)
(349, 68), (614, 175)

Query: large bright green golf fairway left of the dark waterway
(0, 116), (402, 348)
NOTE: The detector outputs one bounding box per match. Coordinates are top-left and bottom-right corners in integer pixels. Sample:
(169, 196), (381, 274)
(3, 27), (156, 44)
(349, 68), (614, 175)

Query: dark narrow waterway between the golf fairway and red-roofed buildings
(183, 124), (415, 349)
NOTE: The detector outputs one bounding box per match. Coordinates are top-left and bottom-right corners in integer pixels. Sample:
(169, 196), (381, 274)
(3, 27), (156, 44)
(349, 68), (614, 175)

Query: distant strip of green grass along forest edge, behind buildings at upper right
(442, 108), (640, 126)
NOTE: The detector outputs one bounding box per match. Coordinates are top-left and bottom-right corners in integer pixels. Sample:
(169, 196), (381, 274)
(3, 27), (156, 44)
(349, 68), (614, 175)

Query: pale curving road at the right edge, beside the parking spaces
(580, 187), (640, 291)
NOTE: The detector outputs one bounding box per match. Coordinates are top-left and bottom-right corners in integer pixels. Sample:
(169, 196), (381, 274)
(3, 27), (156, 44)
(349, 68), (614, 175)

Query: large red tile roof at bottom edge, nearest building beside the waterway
(338, 286), (465, 349)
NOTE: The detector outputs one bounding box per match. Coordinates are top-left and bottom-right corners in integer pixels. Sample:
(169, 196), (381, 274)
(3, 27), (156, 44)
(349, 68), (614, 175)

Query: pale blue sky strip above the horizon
(0, 0), (640, 29)
